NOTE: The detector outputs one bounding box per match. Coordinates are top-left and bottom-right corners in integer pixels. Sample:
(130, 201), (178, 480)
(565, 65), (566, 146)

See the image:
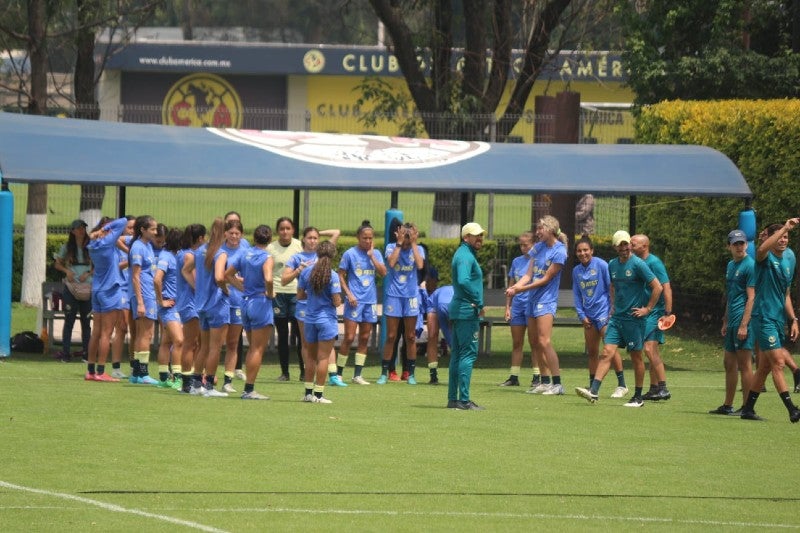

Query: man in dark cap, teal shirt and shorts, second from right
(709, 229), (756, 415)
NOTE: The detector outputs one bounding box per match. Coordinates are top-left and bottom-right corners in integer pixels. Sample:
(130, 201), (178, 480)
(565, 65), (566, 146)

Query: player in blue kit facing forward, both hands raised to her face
(376, 222), (425, 385)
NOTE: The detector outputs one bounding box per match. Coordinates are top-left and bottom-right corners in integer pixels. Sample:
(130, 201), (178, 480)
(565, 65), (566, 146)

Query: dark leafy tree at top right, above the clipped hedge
(617, 0), (800, 105)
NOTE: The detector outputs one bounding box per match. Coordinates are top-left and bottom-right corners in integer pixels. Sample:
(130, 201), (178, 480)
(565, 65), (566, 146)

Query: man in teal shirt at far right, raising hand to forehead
(741, 218), (800, 423)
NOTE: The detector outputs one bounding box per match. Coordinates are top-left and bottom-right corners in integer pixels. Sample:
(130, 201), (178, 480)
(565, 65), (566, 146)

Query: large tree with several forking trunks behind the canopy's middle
(366, 0), (605, 237)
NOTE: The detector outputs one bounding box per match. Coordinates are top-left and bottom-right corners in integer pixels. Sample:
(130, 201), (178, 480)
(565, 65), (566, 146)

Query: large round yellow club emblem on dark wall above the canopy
(161, 74), (242, 128)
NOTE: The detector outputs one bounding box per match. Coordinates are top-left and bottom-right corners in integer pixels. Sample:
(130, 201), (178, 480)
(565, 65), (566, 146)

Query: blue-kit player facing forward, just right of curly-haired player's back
(336, 220), (386, 385)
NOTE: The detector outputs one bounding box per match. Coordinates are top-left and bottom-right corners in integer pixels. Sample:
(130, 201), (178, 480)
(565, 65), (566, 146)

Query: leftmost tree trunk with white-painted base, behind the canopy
(20, 0), (47, 308)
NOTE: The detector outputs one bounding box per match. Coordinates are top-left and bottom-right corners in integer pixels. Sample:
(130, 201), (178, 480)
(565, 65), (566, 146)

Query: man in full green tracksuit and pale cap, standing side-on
(447, 222), (484, 411)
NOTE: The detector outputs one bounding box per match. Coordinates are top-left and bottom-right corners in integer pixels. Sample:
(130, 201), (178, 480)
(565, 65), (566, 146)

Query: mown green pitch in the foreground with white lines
(0, 310), (800, 532)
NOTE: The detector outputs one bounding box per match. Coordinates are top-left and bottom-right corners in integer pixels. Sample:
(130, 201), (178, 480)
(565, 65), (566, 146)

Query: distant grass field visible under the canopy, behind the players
(11, 184), (628, 236)
